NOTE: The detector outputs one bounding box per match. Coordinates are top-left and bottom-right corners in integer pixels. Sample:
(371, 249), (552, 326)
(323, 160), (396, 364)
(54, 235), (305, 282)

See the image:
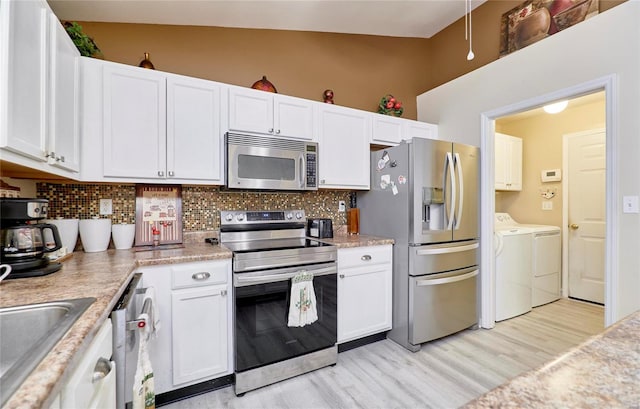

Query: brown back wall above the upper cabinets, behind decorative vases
(80, 22), (430, 119)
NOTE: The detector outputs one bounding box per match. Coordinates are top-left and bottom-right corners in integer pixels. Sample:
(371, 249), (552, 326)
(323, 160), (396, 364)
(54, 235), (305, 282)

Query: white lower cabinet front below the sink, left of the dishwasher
(60, 320), (116, 409)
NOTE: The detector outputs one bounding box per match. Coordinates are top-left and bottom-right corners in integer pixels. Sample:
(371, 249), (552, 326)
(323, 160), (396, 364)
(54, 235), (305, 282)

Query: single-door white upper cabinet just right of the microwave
(318, 103), (371, 190)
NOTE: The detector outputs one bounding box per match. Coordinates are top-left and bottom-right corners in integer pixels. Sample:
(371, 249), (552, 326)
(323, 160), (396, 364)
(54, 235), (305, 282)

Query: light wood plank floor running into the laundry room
(164, 299), (604, 409)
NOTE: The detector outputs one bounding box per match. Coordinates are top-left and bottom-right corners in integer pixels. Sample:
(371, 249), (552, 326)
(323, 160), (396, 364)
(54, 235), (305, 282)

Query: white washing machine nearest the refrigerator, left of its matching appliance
(494, 225), (533, 321)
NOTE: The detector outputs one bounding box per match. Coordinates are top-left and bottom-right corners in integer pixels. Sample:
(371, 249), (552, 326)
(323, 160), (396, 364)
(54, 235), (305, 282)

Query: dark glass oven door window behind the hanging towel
(235, 274), (337, 371)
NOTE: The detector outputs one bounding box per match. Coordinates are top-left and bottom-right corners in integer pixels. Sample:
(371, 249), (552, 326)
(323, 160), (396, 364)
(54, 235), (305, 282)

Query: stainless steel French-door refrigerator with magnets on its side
(357, 138), (480, 351)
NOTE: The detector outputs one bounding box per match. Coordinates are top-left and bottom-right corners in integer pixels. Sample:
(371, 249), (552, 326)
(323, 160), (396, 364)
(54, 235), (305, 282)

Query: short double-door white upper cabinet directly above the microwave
(229, 87), (316, 140)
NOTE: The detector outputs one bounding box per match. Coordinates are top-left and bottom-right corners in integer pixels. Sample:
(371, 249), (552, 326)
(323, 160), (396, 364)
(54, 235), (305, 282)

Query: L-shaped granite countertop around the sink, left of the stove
(0, 243), (232, 408)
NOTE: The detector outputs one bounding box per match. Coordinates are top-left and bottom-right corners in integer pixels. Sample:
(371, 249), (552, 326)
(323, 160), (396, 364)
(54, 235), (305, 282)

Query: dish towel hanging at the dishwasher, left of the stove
(132, 313), (156, 409)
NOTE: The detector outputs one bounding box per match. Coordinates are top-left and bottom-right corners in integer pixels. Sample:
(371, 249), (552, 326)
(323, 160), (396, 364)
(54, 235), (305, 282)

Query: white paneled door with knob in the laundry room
(566, 130), (606, 304)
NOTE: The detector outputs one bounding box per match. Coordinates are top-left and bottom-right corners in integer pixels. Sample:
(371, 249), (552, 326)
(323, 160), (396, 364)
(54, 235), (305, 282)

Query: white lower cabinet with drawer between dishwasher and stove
(138, 260), (233, 394)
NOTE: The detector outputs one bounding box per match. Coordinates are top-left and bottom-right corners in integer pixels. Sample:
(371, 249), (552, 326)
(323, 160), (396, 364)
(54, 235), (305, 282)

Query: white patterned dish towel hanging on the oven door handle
(289, 271), (318, 327)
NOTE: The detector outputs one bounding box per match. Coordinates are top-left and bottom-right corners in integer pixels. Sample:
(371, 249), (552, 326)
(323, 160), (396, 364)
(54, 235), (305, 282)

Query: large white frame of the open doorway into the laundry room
(479, 74), (619, 328)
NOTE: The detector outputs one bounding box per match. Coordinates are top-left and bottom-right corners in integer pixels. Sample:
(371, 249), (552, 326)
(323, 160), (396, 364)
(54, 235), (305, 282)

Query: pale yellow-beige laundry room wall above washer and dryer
(496, 95), (605, 227)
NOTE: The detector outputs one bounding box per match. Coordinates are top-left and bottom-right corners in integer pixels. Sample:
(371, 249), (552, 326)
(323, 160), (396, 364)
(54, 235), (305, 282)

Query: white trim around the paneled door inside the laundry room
(562, 125), (609, 305)
